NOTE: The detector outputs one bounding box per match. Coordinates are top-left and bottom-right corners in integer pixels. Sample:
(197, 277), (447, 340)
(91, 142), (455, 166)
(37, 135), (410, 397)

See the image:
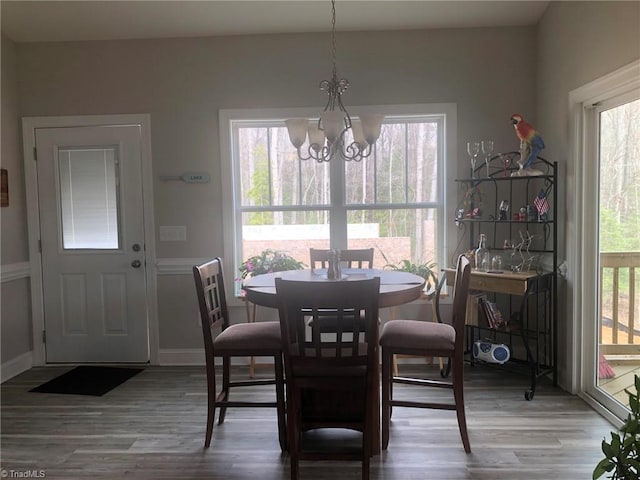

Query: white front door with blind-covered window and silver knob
(35, 125), (149, 363)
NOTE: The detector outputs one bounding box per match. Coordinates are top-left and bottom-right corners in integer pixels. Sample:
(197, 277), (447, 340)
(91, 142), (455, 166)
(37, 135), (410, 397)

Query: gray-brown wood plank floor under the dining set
(1, 366), (612, 480)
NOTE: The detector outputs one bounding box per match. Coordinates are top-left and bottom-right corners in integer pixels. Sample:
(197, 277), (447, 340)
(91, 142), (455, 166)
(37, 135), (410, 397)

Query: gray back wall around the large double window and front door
(10, 28), (535, 356)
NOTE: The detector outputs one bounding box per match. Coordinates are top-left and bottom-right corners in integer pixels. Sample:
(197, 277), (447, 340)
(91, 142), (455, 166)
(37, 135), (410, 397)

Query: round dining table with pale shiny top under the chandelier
(242, 268), (425, 455)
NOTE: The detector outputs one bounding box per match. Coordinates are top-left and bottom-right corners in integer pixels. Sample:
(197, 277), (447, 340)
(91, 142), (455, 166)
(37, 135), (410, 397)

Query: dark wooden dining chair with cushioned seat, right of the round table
(380, 255), (471, 453)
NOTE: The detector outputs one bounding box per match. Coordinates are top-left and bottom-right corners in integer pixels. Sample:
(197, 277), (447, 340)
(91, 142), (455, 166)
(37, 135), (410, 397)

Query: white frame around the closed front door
(22, 114), (159, 366)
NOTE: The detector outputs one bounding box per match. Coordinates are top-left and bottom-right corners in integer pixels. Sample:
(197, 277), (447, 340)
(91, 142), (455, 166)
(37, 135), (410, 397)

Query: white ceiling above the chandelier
(0, 0), (549, 42)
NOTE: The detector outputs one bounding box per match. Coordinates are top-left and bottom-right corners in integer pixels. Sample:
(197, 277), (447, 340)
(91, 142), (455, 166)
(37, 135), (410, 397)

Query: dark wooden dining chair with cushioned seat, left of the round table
(193, 257), (287, 451)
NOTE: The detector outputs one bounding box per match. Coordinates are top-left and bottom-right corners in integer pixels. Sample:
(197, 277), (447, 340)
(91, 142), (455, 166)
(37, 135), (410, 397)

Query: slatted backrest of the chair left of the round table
(193, 257), (229, 356)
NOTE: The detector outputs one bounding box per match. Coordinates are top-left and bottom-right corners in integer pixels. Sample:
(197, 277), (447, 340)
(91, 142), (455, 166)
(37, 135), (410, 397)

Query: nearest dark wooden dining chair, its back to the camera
(276, 277), (380, 480)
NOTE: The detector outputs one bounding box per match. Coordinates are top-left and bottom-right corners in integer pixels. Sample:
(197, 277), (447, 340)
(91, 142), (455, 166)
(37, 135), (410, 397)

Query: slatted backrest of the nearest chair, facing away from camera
(276, 277), (380, 366)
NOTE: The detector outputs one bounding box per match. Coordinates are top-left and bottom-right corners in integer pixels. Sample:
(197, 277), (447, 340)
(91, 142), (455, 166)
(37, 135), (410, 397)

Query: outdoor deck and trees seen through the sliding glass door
(594, 91), (640, 406)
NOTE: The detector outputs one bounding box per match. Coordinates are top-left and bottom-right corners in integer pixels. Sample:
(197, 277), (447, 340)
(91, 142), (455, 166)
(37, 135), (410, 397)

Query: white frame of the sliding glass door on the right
(566, 61), (640, 424)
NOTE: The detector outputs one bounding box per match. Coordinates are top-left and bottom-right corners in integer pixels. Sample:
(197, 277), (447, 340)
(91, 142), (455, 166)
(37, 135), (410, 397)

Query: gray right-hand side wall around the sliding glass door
(536, 2), (640, 385)
